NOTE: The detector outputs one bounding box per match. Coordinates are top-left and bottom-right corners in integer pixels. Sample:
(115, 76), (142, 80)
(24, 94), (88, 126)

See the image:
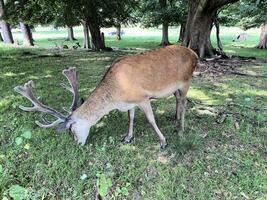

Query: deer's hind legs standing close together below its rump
(174, 84), (189, 136)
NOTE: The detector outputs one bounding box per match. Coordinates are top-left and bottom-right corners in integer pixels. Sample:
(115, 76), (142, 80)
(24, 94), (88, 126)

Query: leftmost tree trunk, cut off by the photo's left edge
(0, 0), (14, 44)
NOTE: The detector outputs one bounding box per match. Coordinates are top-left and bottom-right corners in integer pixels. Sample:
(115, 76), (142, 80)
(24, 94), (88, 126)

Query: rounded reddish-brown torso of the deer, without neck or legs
(102, 45), (197, 102)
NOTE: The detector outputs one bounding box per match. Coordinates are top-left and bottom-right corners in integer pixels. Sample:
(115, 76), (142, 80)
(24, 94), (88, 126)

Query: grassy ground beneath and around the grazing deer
(0, 27), (267, 200)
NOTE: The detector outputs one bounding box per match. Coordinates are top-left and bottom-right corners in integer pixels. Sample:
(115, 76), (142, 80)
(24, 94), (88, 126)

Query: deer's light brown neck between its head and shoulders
(73, 86), (115, 126)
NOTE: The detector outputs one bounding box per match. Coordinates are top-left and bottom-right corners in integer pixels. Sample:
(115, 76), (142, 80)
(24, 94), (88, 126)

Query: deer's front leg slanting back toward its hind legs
(138, 100), (167, 149)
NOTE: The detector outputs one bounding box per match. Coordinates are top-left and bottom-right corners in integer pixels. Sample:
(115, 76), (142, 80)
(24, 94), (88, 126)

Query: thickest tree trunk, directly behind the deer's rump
(183, 0), (238, 58)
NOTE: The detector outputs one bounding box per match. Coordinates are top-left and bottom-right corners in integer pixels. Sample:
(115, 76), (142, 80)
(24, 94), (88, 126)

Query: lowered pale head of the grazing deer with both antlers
(14, 68), (90, 145)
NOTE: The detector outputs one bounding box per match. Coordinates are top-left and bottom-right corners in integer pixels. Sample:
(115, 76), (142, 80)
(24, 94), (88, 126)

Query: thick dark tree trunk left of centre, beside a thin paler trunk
(88, 20), (106, 51)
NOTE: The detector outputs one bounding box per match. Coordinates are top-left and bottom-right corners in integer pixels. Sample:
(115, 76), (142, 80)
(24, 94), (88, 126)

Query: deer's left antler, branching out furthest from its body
(14, 81), (66, 128)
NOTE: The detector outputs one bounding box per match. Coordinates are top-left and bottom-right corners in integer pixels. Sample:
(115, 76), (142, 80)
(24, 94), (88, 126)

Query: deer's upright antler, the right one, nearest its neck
(61, 67), (79, 111)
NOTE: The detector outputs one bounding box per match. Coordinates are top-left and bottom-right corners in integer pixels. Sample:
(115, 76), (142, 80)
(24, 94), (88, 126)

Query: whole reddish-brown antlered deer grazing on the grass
(14, 45), (198, 149)
